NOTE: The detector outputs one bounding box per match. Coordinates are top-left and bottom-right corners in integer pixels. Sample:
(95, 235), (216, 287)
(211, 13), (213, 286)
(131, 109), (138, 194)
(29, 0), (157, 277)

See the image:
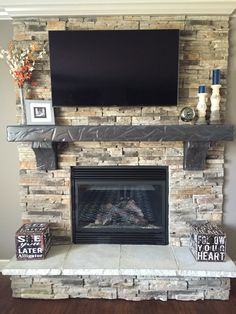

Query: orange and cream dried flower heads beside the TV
(0, 41), (46, 88)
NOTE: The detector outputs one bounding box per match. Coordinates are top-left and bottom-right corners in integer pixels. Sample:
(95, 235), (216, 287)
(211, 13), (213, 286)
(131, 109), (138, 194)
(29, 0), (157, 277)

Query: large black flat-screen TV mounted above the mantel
(49, 30), (179, 106)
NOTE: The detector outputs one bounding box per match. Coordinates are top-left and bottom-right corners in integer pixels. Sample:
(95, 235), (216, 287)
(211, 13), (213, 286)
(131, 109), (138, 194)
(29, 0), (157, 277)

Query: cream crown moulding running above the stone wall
(0, 0), (236, 19)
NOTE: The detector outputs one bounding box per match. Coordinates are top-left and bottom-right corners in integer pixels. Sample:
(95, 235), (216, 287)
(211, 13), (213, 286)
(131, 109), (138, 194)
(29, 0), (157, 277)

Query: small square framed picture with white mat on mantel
(25, 99), (55, 125)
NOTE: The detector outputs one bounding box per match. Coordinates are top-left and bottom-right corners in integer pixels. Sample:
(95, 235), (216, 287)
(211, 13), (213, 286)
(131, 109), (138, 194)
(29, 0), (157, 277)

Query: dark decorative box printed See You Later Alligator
(15, 223), (51, 260)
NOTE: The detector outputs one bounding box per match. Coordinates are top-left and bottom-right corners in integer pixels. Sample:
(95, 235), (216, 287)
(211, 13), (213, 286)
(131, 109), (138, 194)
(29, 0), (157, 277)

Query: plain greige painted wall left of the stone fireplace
(0, 21), (21, 259)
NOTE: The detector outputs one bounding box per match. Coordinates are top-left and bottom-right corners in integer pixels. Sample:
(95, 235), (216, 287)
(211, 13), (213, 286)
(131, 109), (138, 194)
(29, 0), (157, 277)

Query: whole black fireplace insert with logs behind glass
(71, 166), (168, 245)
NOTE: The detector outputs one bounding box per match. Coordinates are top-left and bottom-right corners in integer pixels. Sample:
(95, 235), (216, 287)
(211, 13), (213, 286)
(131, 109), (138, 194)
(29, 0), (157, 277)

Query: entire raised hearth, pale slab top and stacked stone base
(2, 244), (236, 301)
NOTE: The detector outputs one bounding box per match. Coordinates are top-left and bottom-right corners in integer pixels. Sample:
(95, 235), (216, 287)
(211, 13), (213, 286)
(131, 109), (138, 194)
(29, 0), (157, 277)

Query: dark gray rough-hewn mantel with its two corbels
(7, 124), (234, 170)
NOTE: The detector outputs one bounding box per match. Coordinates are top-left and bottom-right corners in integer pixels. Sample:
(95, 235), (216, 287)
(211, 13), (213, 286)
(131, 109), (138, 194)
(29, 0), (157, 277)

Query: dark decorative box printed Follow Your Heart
(190, 222), (226, 262)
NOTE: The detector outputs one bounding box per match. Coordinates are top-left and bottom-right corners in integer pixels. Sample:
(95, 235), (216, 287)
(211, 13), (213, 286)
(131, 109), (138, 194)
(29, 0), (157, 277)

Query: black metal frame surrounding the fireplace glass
(71, 166), (169, 245)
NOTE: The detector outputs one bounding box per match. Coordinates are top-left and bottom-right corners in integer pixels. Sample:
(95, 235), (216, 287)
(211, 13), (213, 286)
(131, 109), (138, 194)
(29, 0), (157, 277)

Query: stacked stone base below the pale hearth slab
(12, 276), (230, 301)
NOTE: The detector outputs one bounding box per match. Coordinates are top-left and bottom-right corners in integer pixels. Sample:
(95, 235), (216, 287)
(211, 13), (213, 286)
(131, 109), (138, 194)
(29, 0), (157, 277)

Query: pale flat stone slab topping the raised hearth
(2, 244), (236, 278)
